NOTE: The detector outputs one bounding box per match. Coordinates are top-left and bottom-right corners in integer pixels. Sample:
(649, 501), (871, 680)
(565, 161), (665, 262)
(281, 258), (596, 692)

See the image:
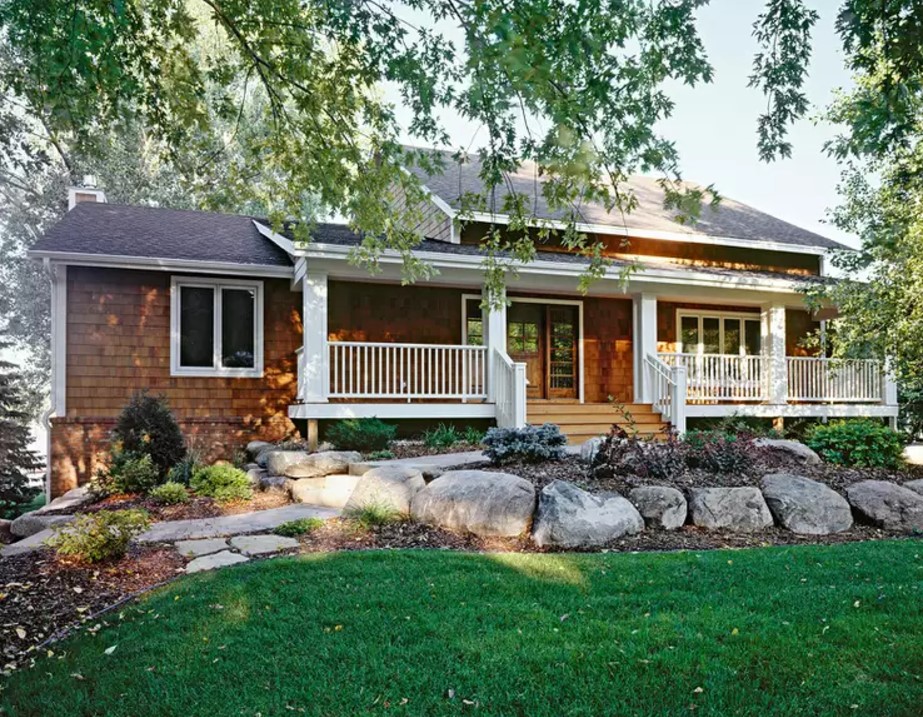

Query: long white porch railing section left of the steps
(327, 341), (487, 402)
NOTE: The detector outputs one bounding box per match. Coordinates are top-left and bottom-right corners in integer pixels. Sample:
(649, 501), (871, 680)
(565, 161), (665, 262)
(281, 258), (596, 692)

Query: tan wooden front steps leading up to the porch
(526, 400), (669, 445)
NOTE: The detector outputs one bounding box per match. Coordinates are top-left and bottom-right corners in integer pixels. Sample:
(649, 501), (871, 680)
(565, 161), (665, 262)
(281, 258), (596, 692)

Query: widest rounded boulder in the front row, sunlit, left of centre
(410, 470), (535, 537)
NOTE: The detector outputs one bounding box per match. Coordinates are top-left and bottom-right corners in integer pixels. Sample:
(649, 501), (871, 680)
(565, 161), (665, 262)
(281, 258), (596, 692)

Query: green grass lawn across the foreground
(0, 541), (923, 717)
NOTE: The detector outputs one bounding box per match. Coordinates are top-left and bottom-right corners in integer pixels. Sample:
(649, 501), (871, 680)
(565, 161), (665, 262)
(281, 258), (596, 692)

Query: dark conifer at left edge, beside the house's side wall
(0, 340), (43, 517)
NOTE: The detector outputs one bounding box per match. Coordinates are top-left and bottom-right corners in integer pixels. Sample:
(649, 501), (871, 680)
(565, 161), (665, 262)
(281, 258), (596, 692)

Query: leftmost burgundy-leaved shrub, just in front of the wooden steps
(591, 426), (686, 480)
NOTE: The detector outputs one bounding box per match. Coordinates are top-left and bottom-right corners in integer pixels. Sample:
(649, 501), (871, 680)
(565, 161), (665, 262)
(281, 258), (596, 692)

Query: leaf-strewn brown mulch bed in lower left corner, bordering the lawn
(0, 546), (185, 672)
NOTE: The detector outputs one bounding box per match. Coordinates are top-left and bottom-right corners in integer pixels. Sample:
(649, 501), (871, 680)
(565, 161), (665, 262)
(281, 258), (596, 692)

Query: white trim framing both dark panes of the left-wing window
(170, 276), (263, 378)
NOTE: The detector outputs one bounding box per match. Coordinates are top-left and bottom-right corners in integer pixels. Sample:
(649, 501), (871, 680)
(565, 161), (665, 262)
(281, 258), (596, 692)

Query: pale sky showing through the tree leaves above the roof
(389, 0), (856, 246)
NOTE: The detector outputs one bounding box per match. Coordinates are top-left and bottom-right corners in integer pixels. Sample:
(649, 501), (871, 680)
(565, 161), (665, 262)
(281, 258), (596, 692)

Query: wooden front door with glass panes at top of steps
(506, 299), (578, 399)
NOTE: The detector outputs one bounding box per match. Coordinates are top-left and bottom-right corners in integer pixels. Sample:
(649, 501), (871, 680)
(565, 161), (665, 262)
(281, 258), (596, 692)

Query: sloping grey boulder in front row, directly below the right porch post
(761, 473), (852, 535)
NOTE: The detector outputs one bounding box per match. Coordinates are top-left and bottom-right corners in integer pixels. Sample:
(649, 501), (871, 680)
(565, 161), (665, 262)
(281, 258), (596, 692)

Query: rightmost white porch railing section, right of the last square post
(785, 356), (885, 403)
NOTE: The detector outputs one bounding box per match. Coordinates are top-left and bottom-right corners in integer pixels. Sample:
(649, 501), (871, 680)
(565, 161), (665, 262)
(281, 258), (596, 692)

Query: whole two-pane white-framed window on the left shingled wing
(170, 277), (263, 378)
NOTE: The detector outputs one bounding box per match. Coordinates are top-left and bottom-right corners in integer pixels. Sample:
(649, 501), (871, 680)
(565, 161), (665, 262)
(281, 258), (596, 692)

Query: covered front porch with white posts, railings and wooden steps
(289, 271), (897, 439)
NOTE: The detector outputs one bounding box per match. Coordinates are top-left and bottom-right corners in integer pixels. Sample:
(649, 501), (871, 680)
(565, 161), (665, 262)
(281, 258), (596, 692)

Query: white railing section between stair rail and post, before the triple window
(660, 353), (770, 401)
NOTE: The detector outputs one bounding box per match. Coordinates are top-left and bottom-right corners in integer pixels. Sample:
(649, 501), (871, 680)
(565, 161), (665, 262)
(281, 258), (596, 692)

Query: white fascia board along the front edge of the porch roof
(299, 243), (816, 293)
